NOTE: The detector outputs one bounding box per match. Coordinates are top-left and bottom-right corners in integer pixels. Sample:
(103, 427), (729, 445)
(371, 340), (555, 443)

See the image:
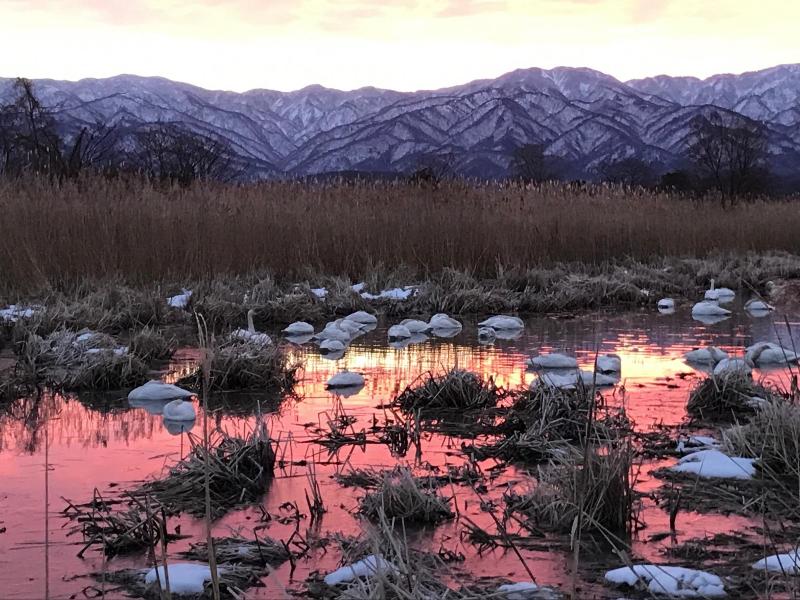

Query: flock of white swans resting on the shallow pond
(117, 279), (800, 423)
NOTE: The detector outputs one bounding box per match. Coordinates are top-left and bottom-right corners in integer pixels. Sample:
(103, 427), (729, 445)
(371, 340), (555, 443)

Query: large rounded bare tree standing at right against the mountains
(689, 111), (767, 202)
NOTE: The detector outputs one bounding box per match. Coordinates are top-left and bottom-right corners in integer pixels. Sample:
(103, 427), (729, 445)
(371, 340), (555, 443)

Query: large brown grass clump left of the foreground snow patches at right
(505, 443), (636, 535)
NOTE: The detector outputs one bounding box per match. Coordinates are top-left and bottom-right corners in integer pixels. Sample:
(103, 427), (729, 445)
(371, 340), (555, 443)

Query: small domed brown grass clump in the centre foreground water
(360, 469), (453, 524)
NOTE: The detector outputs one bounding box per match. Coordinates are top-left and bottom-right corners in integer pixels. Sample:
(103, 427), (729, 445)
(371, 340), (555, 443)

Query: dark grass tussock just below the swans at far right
(686, 374), (778, 421)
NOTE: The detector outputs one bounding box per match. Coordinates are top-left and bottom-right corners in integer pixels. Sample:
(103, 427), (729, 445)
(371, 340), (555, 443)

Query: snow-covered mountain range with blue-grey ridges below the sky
(0, 65), (800, 177)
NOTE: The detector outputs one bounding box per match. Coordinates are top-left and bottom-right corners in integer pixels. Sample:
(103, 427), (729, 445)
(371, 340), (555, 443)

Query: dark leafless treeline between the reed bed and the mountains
(0, 79), (800, 203)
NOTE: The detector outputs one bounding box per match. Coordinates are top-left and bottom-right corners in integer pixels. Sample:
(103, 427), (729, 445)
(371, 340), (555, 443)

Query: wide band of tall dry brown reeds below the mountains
(0, 179), (800, 293)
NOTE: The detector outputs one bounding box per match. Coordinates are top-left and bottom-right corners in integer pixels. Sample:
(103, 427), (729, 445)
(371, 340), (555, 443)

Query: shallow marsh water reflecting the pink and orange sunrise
(0, 310), (800, 599)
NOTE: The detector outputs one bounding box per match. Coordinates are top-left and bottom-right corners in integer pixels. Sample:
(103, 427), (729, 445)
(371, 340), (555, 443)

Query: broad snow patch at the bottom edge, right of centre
(605, 565), (726, 598)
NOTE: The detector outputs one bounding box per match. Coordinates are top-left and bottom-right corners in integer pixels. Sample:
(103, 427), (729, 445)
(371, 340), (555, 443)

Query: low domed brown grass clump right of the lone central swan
(394, 369), (507, 413)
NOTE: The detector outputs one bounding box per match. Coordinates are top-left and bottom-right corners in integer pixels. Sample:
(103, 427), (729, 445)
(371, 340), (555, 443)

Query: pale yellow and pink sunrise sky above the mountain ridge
(0, 0), (800, 91)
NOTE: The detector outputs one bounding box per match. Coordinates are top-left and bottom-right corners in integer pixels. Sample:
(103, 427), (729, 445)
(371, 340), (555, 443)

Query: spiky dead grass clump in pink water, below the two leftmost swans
(132, 432), (275, 518)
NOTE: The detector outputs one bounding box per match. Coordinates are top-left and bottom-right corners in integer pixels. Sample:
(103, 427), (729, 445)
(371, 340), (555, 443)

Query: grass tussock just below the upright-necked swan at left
(179, 342), (300, 393)
